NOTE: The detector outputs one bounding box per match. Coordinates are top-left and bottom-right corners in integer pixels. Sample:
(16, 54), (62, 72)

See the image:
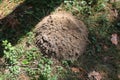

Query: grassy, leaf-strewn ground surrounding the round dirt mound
(0, 0), (120, 80)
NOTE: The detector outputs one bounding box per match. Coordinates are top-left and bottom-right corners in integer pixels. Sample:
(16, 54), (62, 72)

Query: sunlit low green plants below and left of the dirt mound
(2, 38), (60, 80)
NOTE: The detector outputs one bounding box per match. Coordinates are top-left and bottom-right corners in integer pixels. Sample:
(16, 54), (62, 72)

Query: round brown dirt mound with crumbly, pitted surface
(35, 12), (88, 60)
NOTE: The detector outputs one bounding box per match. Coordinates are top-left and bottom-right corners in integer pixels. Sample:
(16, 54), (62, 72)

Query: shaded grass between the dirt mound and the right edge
(60, 2), (120, 80)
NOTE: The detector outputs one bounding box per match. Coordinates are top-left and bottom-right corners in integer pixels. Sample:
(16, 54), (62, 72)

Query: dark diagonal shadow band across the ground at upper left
(0, 0), (63, 57)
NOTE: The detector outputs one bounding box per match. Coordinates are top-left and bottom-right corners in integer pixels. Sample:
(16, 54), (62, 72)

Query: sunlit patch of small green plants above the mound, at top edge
(64, 0), (108, 15)
